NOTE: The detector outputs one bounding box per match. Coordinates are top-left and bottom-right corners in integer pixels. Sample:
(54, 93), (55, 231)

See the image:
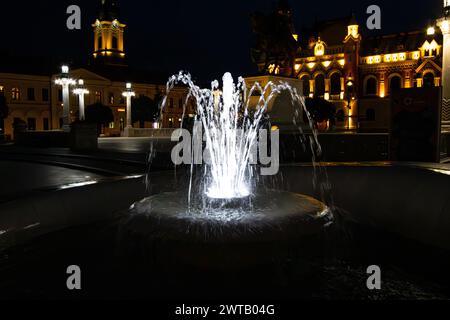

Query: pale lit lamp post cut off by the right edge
(437, 0), (450, 131)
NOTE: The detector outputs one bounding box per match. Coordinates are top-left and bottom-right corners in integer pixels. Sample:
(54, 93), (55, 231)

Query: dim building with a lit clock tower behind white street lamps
(0, 0), (192, 137)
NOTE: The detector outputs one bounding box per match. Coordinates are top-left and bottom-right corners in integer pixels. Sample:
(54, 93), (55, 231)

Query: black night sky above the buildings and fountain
(0, 0), (442, 80)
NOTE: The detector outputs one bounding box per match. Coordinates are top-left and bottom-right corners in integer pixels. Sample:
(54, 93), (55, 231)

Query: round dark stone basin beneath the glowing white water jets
(120, 190), (332, 269)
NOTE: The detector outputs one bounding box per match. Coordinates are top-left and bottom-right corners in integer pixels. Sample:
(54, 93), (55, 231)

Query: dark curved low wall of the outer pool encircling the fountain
(0, 164), (450, 250)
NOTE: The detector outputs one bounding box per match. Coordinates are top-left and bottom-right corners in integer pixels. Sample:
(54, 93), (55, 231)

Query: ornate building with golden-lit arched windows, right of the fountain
(253, 2), (443, 132)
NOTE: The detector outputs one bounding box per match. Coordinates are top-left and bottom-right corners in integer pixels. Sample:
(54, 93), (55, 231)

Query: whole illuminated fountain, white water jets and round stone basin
(123, 73), (332, 267)
